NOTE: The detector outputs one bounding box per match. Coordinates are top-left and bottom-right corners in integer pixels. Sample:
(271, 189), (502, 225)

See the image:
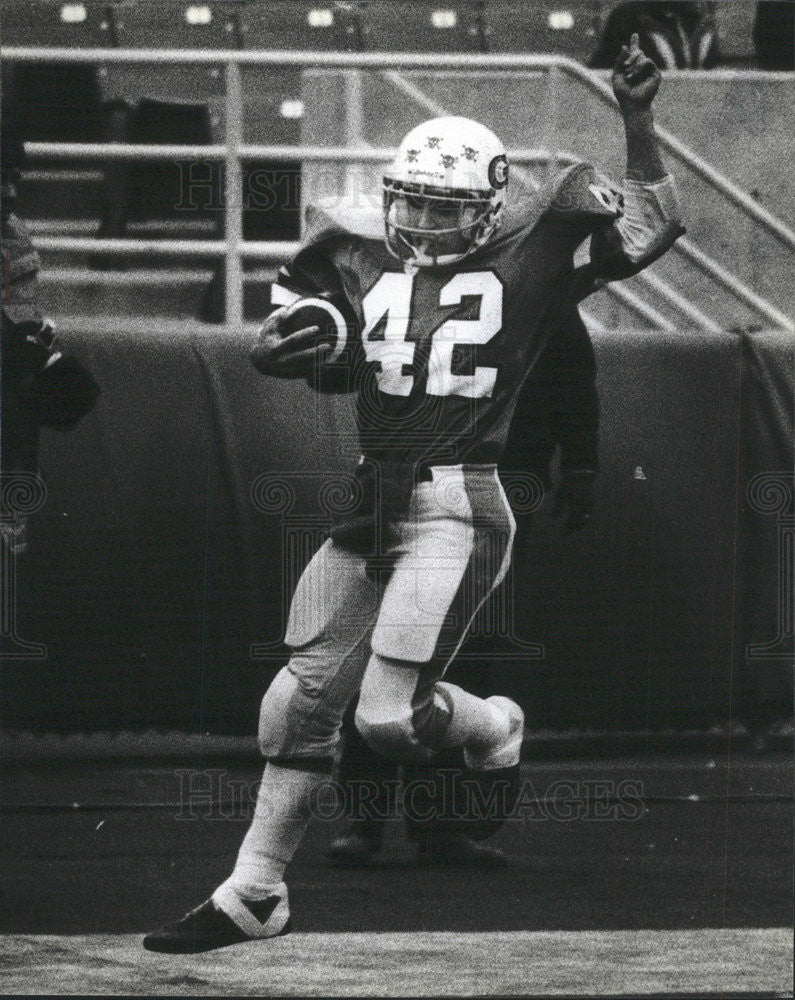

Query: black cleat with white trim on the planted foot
(143, 892), (291, 955)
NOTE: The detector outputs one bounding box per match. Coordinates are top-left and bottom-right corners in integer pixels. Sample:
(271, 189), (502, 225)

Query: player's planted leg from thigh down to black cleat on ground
(144, 542), (379, 952)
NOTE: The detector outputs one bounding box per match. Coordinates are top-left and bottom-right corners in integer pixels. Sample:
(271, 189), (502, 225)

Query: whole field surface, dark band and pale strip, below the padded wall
(0, 754), (793, 998)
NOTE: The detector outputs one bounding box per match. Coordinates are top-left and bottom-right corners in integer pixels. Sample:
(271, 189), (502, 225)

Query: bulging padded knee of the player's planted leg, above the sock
(259, 664), (342, 761)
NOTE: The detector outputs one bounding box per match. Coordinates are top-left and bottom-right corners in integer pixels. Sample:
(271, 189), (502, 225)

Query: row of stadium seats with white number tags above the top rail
(1, 0), (772, 60)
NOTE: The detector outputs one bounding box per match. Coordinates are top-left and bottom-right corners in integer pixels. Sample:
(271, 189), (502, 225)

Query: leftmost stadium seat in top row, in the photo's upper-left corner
(0, 0), (113, 48)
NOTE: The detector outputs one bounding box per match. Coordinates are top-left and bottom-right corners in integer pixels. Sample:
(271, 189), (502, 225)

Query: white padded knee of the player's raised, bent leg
(355, 654), (432, 760)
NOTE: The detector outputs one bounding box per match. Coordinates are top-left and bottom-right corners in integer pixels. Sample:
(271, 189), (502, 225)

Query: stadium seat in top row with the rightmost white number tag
(483, 0), (600, 62)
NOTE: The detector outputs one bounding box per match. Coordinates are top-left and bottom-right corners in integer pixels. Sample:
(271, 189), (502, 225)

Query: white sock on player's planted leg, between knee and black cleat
(216, 763), (328, 900)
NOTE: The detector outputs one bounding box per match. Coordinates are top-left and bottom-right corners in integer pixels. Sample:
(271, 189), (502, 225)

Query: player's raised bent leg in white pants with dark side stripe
(357, 466), (523, 771)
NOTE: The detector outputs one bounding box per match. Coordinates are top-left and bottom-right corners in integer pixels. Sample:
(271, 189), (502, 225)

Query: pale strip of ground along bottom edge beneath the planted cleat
(0, 928), (792, 996)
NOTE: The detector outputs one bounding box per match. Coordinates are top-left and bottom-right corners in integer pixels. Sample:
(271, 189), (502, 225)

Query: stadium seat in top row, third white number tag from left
(240, 0), (359, 51)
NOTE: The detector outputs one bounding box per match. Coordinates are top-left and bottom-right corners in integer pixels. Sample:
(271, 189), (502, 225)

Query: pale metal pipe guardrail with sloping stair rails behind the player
(0, 47), (795, 329)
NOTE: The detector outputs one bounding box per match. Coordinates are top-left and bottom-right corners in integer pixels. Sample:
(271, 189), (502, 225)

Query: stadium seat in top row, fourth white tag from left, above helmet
(358, 0), (483, 52)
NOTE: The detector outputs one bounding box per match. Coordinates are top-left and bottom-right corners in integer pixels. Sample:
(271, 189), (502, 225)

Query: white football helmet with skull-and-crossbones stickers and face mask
(383, 116), (508, 267)
